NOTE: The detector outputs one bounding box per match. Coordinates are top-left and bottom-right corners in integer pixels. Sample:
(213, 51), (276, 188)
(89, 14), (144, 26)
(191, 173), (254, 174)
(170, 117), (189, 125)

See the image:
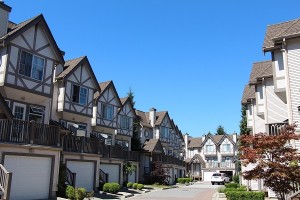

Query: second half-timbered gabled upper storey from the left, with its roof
(52, 56), (100, 137)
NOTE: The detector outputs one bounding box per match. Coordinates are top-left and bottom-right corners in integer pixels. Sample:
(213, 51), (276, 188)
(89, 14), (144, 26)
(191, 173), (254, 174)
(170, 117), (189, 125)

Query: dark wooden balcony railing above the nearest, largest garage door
(0, 119), (60, 147)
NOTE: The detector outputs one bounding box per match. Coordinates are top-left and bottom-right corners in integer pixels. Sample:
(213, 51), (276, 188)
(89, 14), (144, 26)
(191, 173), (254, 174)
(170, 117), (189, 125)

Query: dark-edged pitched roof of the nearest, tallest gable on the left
(0, 14), (65, 64)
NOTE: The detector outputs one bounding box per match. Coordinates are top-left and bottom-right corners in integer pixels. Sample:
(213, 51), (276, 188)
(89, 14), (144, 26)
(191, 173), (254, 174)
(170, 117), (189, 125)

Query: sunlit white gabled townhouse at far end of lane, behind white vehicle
(184, 133), (238, 181)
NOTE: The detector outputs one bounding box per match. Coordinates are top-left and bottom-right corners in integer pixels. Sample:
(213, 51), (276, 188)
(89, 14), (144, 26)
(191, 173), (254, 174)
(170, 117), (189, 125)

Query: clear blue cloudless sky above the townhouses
(5, 0), (300, 137)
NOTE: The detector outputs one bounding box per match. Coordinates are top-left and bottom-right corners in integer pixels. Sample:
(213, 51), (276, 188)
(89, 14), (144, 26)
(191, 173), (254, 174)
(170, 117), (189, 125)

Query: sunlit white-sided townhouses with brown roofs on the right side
(242, 19), (300, 196)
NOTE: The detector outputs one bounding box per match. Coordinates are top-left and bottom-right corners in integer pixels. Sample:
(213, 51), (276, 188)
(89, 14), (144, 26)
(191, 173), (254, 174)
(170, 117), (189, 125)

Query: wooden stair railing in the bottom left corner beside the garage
(0, 164), (12, 200)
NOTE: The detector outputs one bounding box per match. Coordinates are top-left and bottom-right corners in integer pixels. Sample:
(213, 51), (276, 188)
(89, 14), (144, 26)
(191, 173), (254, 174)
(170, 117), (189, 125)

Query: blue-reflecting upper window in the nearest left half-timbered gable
(19, 51), (45, 81)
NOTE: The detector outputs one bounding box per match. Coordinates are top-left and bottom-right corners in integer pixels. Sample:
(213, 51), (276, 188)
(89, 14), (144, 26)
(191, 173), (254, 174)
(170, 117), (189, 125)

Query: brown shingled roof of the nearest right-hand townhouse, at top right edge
(263, 18), (300, 51)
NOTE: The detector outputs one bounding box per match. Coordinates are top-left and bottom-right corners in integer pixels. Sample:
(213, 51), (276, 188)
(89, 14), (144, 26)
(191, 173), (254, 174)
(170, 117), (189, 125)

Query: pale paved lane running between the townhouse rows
(128, 182), (220, 200)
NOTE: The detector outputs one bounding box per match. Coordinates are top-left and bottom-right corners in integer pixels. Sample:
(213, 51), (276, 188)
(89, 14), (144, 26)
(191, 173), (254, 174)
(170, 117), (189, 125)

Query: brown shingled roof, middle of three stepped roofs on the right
(249, 60), (273, 84)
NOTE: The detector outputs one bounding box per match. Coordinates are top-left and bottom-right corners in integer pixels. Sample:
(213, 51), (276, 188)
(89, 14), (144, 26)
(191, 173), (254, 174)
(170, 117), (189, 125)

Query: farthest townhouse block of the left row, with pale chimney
(136, 108), (185, 184)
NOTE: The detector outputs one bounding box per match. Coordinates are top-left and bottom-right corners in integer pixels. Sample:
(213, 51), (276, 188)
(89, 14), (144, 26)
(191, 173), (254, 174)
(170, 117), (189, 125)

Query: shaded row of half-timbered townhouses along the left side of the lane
(0, 2), (188, 199)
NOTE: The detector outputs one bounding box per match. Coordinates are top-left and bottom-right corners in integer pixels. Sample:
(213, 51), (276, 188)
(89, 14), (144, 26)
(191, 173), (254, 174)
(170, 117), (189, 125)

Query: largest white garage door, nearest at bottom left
(4, 155), (52, 200)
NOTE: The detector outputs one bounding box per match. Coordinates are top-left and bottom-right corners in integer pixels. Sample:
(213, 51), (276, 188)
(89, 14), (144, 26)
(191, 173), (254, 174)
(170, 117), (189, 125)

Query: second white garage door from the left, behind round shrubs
(67, 161), (95, 192)
